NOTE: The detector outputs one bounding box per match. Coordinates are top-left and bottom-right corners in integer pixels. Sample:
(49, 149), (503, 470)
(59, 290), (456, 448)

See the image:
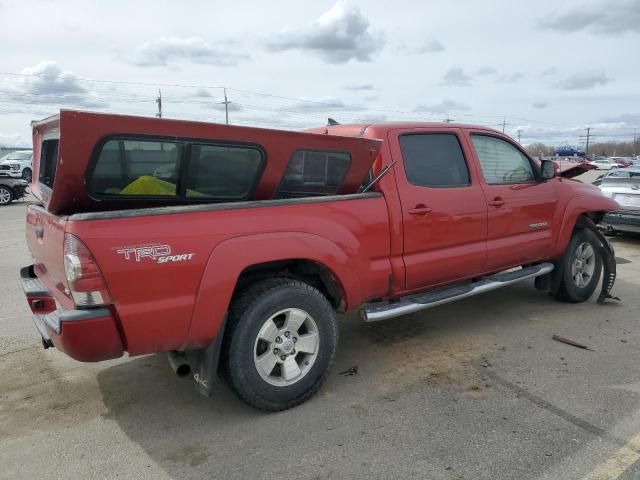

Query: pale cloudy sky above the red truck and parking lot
(0, 0), (640, 146)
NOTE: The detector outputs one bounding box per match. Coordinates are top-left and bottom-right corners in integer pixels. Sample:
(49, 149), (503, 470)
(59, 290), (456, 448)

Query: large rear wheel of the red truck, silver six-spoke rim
(222, 278), (338, 412)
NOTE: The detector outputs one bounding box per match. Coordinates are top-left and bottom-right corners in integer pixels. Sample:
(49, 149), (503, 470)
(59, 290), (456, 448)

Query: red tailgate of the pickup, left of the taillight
(25, 205), (73, 308)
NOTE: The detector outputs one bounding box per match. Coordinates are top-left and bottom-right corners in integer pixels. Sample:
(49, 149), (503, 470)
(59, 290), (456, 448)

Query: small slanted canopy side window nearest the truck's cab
(278, 150), (351, 197)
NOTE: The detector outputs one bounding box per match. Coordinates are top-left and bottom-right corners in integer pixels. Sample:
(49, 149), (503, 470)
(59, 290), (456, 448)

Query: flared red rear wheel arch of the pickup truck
(186, 232), (363, 348)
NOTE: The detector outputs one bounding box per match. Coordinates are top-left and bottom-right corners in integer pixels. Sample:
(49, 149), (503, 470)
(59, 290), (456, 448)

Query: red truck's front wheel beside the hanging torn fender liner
(552, 229), (602, 303)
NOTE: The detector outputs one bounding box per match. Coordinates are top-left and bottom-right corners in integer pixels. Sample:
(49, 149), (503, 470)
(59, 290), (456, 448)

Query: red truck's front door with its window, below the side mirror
(469, 132), (556, 271)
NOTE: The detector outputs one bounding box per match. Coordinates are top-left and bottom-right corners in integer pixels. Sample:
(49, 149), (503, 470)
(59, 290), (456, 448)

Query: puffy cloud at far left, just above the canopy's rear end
(7, 61), (107, 108)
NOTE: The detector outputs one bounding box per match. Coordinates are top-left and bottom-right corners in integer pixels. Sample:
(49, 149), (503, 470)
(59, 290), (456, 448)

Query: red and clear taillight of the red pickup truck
(64, 233), (111, 307)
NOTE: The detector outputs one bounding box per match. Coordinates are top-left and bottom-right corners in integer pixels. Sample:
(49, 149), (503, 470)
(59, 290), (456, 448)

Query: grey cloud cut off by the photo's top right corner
(538, 0), (640, 35)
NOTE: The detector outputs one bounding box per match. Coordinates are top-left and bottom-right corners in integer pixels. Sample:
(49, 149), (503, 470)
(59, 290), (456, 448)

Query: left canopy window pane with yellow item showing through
(90, 139), (183, 197)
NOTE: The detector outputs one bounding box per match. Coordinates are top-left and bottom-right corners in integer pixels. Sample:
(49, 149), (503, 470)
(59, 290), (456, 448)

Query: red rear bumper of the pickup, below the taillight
(20, 265), (124, 362)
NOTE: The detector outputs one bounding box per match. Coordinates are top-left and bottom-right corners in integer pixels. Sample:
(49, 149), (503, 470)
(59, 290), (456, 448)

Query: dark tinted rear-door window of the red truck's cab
(400, 133), (470, 187)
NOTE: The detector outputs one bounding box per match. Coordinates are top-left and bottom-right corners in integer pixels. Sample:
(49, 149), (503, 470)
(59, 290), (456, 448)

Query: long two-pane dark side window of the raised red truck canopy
(87, 138), (264, 201)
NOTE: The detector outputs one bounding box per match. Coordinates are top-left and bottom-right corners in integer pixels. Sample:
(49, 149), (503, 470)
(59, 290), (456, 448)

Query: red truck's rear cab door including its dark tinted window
(389, 128), (487, 290)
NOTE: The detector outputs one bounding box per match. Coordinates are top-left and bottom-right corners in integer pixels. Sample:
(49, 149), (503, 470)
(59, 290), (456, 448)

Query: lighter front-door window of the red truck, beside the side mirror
(471, 135), (535, 184)
